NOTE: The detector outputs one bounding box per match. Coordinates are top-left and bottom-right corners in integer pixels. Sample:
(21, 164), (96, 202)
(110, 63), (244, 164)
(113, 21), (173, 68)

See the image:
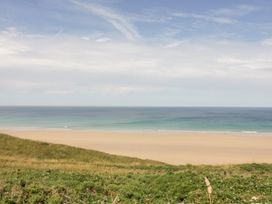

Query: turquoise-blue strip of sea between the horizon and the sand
(0, 107), (272, 132)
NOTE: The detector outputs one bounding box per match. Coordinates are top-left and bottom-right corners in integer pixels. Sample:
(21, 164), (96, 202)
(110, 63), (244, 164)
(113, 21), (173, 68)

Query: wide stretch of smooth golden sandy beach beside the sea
(1, 130), (272, 164)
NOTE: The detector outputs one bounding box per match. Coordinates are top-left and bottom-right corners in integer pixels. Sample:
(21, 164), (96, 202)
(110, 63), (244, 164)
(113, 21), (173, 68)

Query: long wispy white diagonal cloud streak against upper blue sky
(71, 0), (140, 40)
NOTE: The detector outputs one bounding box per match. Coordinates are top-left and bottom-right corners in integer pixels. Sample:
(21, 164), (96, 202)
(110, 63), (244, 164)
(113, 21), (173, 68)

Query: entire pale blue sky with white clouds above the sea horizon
(0, 0), (272, 107)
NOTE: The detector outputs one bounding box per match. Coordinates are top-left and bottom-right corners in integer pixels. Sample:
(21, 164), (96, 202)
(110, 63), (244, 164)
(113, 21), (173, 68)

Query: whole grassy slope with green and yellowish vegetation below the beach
(0, 134), (272, 203)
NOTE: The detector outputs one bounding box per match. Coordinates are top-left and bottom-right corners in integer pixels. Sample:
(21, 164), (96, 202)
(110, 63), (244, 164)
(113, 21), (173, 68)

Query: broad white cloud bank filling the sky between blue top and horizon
(0, 27), (272, 105)
